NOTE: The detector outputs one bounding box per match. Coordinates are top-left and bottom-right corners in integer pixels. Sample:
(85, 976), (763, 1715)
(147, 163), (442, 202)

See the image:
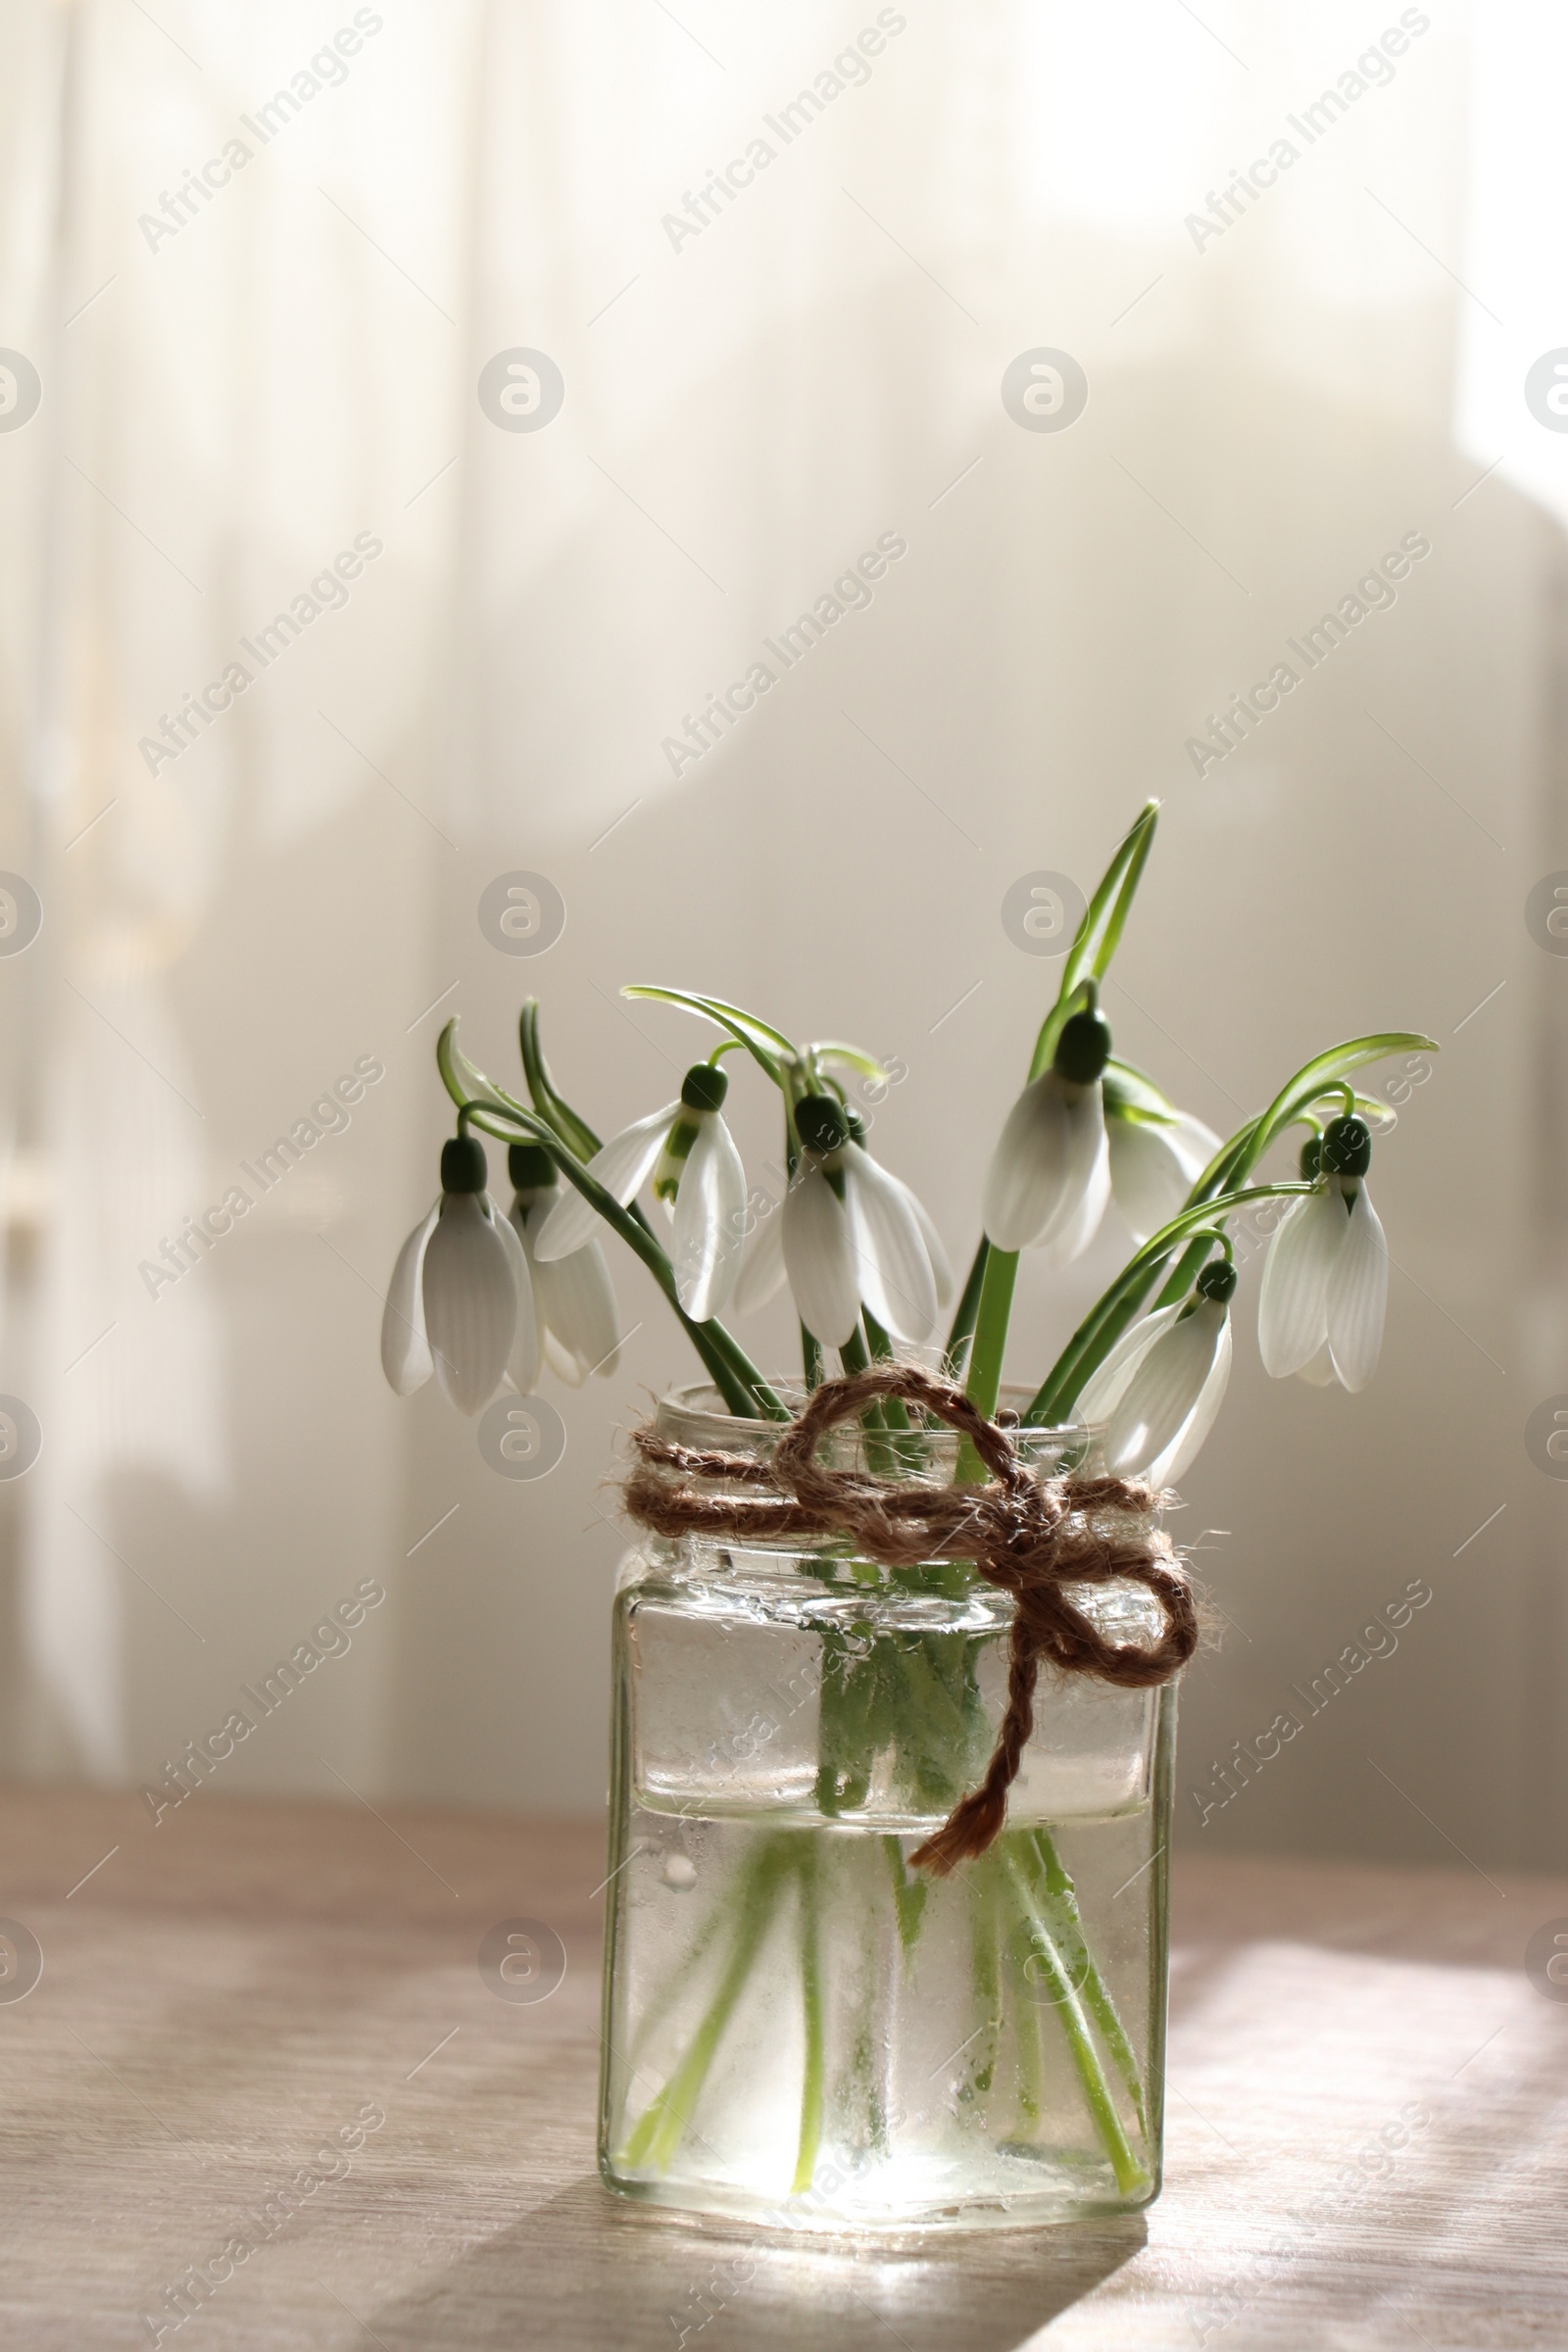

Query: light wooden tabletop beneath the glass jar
(0, 1789), (1568, 2352)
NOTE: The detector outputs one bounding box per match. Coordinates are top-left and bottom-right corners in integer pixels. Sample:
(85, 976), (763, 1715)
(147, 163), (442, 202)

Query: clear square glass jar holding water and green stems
(600, 1390), (1175, 2232)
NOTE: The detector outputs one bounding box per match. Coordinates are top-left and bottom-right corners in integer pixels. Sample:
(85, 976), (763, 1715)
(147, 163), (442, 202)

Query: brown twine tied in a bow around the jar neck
(623, 1364), (1199, 1877)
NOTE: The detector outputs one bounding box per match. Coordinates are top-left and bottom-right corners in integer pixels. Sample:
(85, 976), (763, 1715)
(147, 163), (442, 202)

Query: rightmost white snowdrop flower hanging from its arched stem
(1257, 1112), (1390, 1393)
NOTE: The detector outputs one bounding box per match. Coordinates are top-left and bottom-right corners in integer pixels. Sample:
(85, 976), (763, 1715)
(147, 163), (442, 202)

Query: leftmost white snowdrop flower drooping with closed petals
(381, 1136), (516, 1413)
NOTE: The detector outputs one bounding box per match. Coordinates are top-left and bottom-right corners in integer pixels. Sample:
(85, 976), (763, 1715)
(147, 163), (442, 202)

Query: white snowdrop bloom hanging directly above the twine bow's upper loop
(775, 1094), (953, 1348)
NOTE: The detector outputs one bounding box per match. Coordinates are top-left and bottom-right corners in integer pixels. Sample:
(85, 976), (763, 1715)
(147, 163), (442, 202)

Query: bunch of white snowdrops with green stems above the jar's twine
(381, 802), (1434, 1487)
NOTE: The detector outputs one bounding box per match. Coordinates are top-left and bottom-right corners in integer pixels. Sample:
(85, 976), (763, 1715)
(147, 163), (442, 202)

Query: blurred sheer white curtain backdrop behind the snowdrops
(0, 0), (1568, 1863)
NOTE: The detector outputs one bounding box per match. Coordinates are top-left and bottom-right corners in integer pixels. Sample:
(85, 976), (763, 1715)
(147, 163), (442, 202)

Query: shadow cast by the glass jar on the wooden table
(373, 2180), (1148, 2352)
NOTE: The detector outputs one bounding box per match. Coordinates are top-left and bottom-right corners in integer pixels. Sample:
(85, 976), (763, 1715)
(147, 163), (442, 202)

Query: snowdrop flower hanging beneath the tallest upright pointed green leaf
(983, 1013), (1109, 1265)
